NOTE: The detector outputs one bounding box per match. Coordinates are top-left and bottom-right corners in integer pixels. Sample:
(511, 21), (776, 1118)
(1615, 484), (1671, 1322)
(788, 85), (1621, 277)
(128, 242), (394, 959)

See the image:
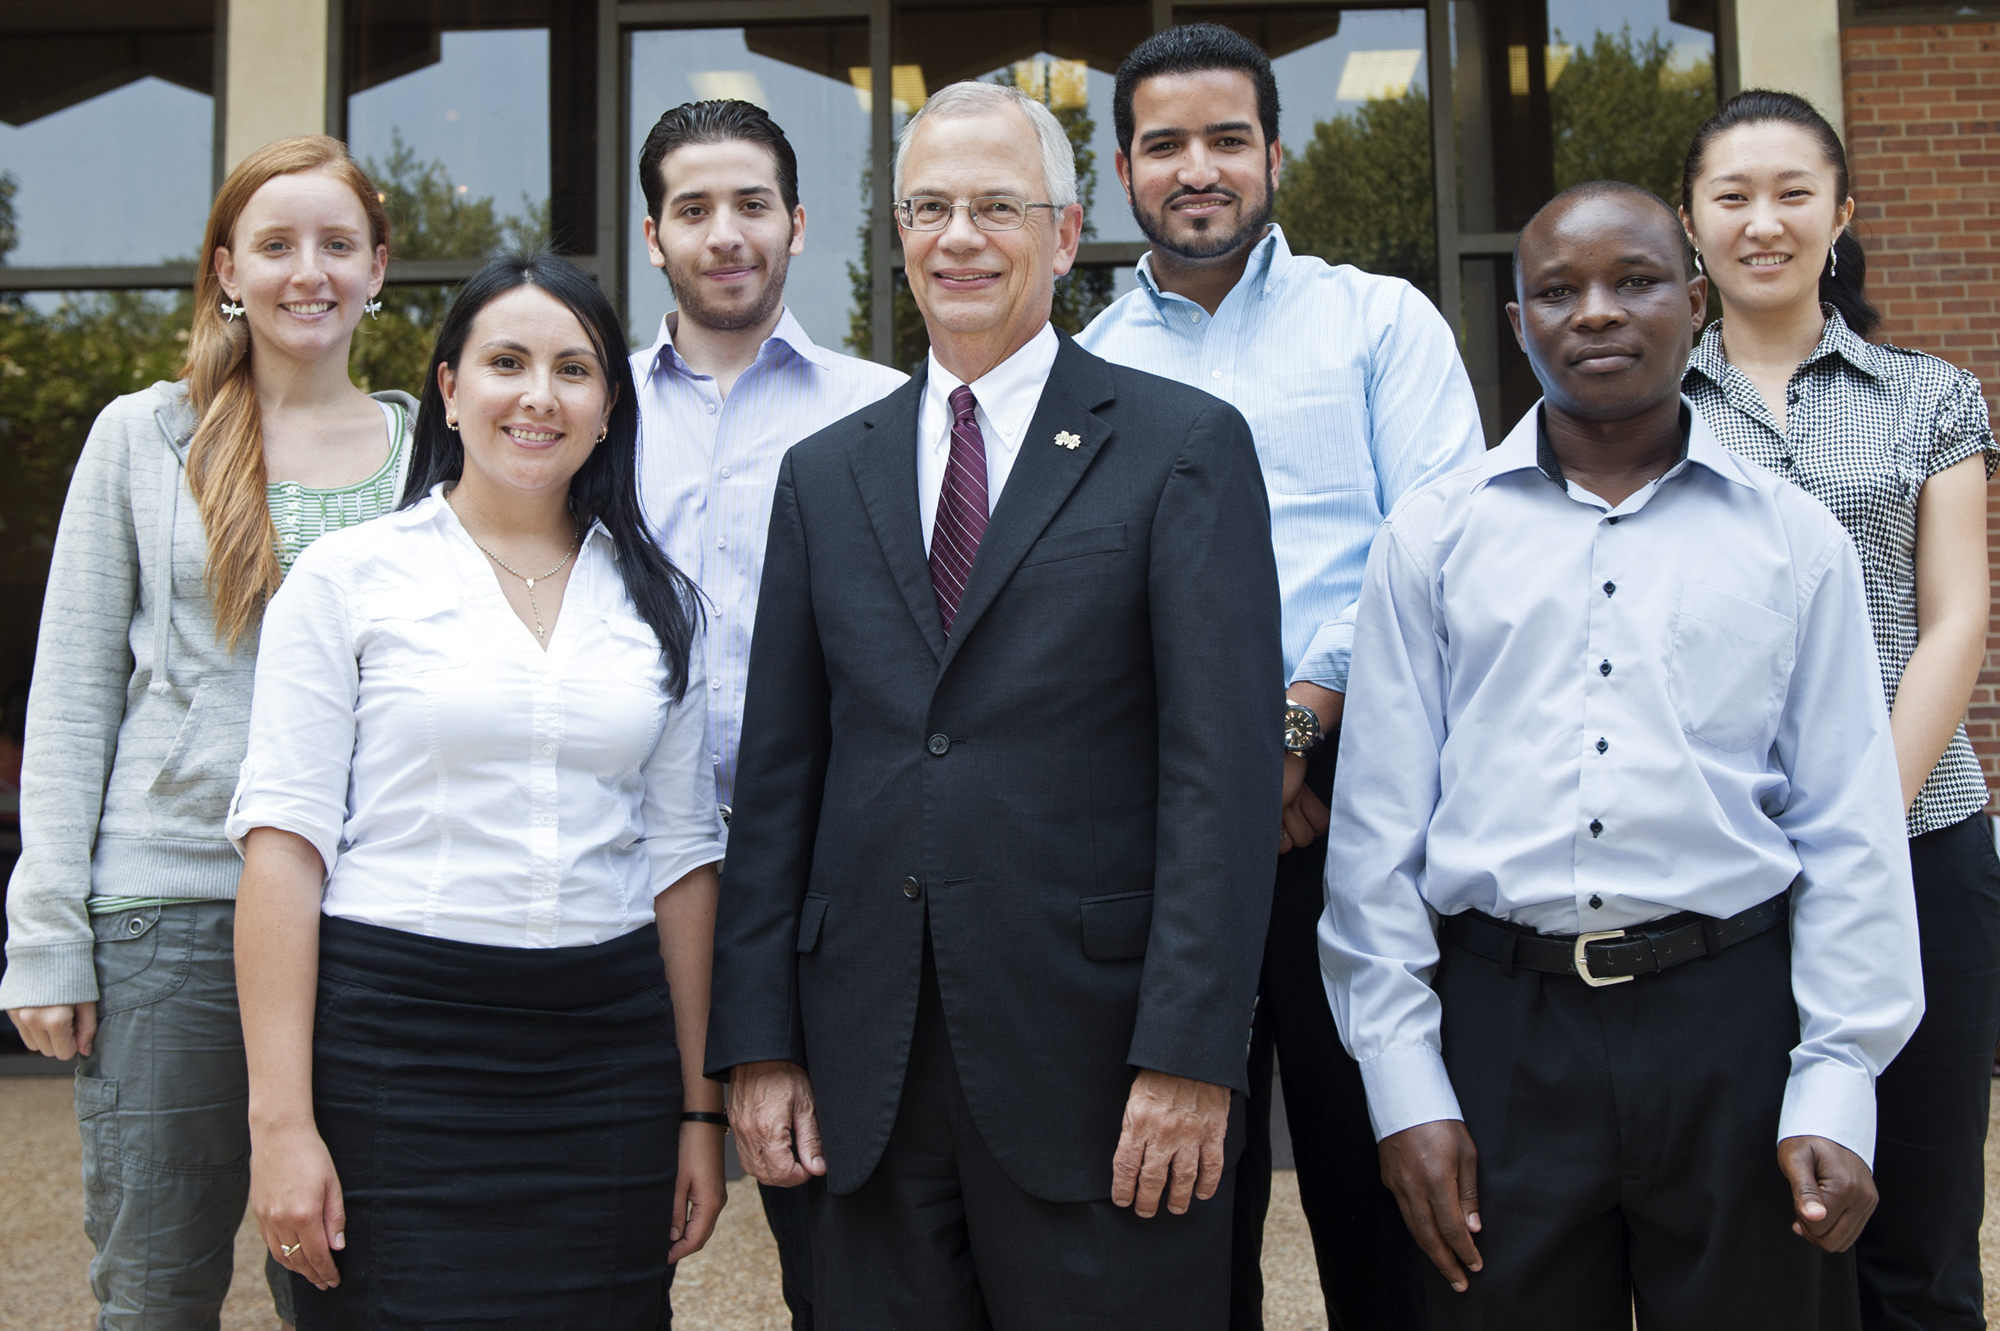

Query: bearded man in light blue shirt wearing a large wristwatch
(1078, 24), (1482, 1331)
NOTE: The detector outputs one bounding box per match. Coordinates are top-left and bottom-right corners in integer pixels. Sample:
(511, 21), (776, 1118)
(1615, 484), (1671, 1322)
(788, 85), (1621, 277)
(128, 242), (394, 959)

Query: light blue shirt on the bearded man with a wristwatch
(1078, 224), (1486, 693)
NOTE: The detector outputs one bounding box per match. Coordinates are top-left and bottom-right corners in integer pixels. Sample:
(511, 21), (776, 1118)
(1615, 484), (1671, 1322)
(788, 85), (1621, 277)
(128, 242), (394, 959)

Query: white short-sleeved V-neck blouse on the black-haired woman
(228, 486), (722, 947)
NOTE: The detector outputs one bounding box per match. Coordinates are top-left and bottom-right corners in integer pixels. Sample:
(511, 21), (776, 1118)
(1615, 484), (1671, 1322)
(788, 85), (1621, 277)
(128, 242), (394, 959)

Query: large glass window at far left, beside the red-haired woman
(0, 0), (216, 719)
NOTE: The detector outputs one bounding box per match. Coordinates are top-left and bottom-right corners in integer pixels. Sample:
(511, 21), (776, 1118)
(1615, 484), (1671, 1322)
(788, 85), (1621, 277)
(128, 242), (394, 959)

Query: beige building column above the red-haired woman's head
(222, 0), (328, 172)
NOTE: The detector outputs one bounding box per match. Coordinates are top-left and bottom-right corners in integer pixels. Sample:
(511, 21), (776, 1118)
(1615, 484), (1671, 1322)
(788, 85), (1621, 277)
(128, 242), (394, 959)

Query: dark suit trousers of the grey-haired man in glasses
(804, 939), (1236, 1331)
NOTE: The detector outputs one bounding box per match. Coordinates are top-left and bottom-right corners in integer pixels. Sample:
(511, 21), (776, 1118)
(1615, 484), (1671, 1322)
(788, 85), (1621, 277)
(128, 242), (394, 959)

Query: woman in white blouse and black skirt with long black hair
(228, 256), (724, 1331)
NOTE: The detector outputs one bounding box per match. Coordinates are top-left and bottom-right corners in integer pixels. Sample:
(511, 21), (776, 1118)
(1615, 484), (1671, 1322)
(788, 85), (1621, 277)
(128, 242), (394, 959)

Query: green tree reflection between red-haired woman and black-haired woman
(348, 132), (550, 396)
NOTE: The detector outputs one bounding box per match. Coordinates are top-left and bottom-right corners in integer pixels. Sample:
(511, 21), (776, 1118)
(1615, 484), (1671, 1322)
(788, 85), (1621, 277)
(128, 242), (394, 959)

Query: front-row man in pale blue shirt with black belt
(1320, 182), (1924, 1331)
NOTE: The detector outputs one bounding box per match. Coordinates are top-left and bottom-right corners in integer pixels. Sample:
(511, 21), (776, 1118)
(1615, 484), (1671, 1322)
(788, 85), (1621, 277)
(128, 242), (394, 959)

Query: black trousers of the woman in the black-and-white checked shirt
(1822, 813), (2000, 1331)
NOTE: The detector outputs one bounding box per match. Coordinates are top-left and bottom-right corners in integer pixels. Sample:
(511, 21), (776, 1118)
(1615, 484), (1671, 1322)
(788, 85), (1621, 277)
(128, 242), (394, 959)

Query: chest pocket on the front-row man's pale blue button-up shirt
(1668, 582), (1798, 753)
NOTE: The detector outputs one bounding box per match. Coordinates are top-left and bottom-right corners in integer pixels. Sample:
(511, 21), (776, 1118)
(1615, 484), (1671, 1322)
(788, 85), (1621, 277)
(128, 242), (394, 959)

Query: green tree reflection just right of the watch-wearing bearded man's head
(1272, 88), (1438, 300)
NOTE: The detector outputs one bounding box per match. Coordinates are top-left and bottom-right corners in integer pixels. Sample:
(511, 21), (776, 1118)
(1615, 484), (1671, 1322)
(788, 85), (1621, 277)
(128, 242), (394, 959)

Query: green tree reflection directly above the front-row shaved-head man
(1548, 28), (1716, 204)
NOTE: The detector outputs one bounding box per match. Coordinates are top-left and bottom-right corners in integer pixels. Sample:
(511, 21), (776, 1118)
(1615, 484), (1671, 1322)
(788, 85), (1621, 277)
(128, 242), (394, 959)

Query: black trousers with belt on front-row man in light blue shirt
(1426, 895), (1822, 1331)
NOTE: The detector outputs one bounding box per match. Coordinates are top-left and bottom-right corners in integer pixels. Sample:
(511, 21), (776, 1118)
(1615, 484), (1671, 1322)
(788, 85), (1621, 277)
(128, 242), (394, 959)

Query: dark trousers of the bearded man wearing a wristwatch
(1230, 737), (1432, 1331)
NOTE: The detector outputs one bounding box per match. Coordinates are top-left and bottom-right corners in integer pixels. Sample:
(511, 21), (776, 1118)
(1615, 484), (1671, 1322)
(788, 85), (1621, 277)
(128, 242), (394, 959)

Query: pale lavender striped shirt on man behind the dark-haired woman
(632, 310), (908, 803)
